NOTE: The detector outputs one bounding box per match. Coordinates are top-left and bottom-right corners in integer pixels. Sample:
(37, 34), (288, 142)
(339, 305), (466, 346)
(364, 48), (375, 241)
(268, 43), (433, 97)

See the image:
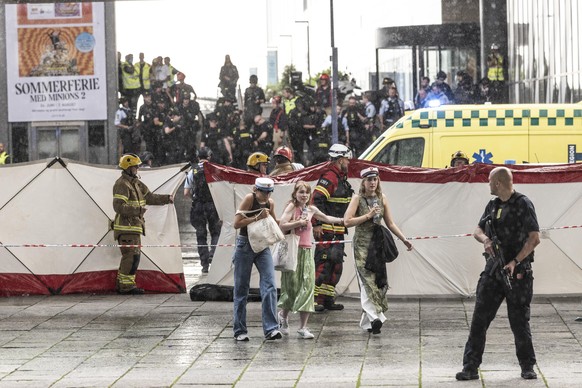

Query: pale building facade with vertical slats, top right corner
(507, 0), (582, 103)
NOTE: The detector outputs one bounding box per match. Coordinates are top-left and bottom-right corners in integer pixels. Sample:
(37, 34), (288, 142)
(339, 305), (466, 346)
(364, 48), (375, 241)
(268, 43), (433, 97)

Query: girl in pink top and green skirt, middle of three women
(278, 181), (343, 339)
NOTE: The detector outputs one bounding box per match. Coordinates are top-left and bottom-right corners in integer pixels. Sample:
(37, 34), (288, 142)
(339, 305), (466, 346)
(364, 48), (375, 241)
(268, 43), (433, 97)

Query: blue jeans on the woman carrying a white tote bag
(232, 236), (279, 337)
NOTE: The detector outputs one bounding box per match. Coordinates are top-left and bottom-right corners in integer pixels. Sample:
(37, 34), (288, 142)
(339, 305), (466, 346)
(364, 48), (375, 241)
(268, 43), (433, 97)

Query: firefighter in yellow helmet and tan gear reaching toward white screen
(113, 154), (174, 294)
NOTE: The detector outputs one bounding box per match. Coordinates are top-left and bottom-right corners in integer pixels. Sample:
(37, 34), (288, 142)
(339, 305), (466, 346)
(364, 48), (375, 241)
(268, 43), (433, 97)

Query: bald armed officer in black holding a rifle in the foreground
(456, 167), (540, 380)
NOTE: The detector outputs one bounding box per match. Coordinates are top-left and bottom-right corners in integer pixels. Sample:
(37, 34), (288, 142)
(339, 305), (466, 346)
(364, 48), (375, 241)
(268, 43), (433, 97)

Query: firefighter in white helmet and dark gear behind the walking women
(313, 144), (354, 312)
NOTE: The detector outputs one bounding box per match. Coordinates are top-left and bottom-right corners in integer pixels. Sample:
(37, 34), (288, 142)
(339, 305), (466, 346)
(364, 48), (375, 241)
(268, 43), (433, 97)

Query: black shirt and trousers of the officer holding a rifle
(463, 192), (539, 371)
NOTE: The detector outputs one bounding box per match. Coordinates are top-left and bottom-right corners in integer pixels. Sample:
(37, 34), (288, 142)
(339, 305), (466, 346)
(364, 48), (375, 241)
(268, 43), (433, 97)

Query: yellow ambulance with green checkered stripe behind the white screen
(360, 102), (582, 168)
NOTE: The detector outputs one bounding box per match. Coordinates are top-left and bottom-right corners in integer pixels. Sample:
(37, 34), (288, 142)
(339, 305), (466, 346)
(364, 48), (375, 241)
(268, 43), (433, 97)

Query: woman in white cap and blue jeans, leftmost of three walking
(232, 178), (282, 341)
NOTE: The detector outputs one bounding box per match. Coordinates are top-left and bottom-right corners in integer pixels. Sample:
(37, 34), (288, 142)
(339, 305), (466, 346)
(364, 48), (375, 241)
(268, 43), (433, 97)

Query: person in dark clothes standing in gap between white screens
(184, 147), (222, 273)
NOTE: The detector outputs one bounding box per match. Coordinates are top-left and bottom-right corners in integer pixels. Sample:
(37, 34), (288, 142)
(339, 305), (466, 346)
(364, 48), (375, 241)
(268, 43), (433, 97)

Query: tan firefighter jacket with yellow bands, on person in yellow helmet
(113, 171), (170, 240)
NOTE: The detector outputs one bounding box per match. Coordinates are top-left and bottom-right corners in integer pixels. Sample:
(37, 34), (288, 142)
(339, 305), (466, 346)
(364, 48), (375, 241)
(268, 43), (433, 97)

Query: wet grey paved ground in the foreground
(0, 258), (582, 388)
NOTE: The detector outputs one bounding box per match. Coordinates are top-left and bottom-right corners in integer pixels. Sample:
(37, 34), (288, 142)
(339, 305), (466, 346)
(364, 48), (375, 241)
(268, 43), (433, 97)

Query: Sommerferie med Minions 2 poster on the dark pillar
(6, 3), (107, 122)
